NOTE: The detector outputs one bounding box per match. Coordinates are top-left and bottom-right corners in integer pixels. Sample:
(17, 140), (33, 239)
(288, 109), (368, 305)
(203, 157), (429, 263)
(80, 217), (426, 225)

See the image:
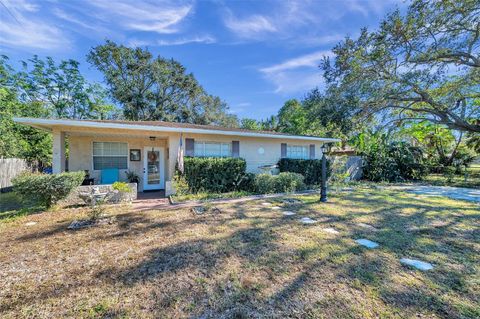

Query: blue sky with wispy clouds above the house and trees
(0, 0), (404, 119)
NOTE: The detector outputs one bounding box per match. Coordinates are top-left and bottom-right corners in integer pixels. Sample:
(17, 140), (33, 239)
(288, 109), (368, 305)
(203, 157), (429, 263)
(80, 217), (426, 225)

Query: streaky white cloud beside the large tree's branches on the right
(259, 51), (332, 93)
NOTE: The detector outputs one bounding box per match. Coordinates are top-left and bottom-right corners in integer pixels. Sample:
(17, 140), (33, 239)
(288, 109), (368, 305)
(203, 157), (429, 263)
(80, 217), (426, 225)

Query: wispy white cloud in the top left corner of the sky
(0, 0), (70, 50)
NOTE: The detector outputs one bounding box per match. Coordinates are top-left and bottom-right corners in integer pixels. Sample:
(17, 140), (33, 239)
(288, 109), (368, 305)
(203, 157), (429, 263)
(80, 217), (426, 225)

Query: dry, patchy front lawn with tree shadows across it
(0, 188), (480, 318)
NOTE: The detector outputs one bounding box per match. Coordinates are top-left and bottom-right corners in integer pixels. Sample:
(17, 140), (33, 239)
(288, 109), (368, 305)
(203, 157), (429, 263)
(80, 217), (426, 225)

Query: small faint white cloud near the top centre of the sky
(224, 11), (277, 38)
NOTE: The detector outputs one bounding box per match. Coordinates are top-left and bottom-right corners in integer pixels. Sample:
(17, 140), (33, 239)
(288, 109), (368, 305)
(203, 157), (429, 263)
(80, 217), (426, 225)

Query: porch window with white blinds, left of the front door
(93, 142), (128, 170)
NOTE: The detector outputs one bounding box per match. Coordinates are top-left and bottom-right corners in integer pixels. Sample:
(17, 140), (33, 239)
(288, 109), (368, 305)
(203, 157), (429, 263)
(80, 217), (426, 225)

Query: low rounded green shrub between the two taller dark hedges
(254, 172), (305, 194)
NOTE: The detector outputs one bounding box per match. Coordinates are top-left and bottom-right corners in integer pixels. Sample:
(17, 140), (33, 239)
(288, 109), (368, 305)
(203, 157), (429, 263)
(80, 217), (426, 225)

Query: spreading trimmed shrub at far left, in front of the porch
(12, 171), (85, 208)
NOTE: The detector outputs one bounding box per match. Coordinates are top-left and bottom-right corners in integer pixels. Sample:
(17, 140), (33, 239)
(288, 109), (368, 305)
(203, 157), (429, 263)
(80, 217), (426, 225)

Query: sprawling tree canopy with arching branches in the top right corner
(321, 0), (480, 132)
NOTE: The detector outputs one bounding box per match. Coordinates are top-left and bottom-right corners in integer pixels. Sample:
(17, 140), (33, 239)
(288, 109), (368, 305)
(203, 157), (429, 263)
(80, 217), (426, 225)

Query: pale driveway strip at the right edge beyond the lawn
(401, 186), (480, 203)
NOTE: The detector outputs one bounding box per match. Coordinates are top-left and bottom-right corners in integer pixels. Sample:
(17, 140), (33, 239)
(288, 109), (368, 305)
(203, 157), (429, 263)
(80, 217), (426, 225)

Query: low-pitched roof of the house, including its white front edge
(13, 117), (341, 143)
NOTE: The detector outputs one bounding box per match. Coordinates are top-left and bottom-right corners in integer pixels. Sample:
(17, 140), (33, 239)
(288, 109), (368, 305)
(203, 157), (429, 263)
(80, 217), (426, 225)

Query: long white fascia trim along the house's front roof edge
(13, 117), (341, 143)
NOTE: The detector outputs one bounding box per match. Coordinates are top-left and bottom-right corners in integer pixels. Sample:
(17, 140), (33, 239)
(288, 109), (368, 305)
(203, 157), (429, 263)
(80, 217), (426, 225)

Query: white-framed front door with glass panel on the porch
(143, 147), (165, 190)
